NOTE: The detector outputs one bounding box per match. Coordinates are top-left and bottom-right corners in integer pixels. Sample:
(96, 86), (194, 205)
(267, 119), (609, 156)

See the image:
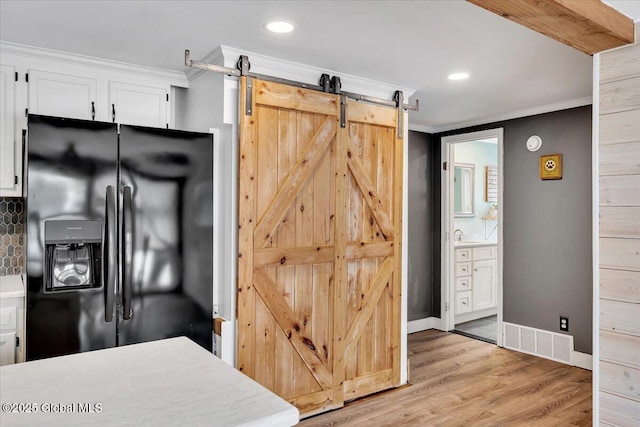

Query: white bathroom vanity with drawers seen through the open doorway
(455, 242), (498, 323)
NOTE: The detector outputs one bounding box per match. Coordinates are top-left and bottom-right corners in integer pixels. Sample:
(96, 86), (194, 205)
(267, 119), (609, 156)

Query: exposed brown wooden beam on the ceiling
(467, 0), (634, 55)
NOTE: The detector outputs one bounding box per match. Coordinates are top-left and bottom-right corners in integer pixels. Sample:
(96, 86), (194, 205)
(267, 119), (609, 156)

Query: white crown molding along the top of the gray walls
(409, 96), (593, 134)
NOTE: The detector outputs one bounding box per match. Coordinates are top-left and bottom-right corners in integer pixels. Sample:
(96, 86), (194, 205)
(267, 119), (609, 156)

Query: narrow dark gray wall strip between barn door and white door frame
(407, 131), (439, 321)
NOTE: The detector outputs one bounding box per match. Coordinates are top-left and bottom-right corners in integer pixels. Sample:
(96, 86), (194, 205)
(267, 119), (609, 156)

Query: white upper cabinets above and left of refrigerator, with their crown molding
(0, 41), (189, 197)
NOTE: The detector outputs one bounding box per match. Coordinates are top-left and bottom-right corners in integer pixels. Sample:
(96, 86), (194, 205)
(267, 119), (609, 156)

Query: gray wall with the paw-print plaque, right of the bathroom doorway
(436, 106), (593, 354)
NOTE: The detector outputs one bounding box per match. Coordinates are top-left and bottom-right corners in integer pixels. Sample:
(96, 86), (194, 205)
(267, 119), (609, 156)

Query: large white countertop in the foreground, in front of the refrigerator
(0, 337), (299, 426)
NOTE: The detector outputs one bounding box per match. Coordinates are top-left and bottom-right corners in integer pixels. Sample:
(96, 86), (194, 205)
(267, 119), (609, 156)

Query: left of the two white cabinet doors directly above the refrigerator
(29, 69), (98, 120)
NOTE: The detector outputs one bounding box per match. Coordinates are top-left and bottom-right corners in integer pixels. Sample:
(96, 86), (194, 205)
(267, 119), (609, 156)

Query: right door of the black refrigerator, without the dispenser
(119, 125), (213, 351)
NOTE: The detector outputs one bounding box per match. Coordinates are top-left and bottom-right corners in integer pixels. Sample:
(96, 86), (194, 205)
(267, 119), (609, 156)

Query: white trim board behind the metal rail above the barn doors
(187, 45), (415, 101)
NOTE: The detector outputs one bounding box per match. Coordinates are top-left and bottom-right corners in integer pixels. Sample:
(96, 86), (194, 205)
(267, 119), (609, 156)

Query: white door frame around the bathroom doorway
(440, 128), (504, 347)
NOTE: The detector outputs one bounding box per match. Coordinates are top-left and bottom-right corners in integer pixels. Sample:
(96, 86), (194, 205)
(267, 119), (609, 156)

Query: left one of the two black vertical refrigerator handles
(103, 185), (118, 322)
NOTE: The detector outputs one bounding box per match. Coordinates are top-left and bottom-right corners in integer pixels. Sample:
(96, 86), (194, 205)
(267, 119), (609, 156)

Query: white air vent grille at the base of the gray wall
(503, 322), (573, 365)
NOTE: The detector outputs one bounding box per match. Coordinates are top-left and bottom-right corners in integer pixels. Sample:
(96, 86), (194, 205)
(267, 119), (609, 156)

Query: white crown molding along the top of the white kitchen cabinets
(0, 41), (189, 87)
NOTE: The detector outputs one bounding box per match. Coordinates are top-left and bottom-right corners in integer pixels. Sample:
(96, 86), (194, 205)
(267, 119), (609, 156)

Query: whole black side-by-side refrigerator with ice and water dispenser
(25, 115), (213, 360)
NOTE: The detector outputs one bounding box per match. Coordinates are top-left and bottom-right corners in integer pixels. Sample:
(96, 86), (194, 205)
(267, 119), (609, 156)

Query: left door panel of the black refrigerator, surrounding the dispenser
(26, 115), (117, 360)
